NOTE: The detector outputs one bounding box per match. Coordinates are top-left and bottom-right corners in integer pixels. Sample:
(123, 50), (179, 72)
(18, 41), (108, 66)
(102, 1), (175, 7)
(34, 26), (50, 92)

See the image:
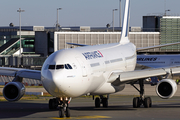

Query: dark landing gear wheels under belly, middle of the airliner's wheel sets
(93, 95), (109, 108)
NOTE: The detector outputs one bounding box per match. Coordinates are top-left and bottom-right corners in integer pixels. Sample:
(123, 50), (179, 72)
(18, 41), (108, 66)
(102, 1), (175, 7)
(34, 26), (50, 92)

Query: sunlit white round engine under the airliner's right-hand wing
(156, 79), (177, 99)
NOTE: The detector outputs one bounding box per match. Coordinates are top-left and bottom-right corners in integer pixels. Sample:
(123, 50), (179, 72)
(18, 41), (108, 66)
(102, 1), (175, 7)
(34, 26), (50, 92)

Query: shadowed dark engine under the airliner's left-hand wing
(3, 82), (25, 101)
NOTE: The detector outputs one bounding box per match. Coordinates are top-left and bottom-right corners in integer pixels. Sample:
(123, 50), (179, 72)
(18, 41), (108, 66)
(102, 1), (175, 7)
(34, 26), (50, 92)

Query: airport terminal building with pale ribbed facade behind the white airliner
(0, 16), (180, 66)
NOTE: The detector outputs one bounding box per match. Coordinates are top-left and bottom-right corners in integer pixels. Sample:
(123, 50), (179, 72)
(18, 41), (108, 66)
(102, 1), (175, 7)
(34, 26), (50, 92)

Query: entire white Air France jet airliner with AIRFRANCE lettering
(0, 0), (180, 117)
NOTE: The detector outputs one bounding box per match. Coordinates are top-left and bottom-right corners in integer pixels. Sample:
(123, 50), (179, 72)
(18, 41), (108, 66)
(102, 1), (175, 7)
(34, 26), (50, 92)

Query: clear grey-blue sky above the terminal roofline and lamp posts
(0, 0), (180, 27)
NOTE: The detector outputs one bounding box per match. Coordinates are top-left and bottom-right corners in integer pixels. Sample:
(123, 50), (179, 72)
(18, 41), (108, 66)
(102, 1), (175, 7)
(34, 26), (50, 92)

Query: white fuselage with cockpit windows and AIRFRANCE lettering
(41, 43), (136, 97)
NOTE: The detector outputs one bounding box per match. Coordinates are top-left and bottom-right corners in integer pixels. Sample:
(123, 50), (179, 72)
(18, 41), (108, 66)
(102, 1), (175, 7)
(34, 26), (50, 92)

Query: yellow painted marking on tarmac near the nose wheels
(52, 115), (111, 120)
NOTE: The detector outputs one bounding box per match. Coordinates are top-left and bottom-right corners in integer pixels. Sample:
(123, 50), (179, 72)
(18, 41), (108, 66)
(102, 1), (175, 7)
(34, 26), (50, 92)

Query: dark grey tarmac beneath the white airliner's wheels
(0, 84), (180, 120)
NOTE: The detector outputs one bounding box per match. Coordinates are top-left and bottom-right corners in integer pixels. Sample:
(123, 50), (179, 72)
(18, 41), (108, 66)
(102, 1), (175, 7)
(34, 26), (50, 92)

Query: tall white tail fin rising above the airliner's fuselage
(119, 0), (130, 44)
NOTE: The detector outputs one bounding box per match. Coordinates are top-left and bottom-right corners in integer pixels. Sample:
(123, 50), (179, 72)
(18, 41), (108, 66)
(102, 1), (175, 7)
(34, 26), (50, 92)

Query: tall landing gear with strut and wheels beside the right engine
(131, 79), (152, 108)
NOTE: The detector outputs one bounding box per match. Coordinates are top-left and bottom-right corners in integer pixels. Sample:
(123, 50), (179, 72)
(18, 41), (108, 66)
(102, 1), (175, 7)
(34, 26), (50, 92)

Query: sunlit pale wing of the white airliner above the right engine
(107, 67), (180, 84)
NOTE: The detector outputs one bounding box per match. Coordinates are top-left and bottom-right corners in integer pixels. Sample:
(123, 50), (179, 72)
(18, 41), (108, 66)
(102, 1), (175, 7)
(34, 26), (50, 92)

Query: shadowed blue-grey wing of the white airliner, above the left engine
(0, 67), (41, 80)
